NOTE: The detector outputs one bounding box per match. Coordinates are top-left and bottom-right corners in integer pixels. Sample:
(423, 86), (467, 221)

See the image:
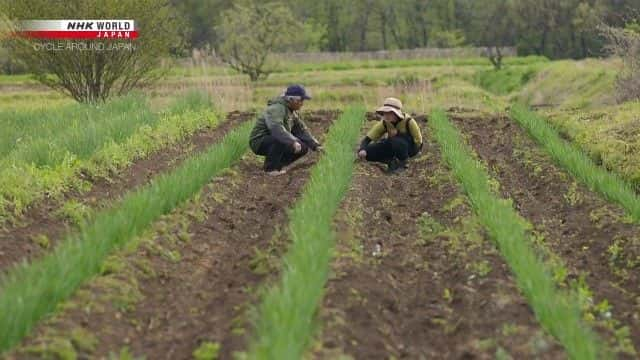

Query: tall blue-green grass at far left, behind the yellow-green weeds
(0, 92), (212, 166)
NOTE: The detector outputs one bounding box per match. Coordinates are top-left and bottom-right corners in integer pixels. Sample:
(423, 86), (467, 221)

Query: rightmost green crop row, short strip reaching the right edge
(511, 104), (640, 222)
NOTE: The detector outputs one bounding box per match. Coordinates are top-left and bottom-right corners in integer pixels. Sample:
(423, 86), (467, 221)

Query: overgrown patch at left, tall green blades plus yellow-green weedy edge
(0, 91), (218, 223)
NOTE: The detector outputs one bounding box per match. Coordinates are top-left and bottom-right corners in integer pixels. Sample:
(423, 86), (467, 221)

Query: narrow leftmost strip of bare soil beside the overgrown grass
(0, 112), (253, 272)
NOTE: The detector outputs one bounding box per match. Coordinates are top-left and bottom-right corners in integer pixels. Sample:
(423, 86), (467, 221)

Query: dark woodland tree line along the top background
(178, 0), (640, 59)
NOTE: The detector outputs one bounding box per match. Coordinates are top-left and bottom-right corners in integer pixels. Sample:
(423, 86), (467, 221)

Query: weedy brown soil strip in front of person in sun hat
(312, 121), (564, 359)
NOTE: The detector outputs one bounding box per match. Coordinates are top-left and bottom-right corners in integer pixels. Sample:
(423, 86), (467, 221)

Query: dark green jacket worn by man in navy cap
(249, 96), (320, 152)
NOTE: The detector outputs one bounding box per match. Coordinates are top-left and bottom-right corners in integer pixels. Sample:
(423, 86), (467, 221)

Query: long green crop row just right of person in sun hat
(429, 110), (602, 359)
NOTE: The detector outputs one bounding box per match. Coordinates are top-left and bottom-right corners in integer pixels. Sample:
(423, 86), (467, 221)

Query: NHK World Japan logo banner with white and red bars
(18, 20), (138, 40)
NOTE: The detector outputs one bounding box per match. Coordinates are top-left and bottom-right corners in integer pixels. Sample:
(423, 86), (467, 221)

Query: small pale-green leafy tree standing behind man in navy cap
(217, 1), (302, 81)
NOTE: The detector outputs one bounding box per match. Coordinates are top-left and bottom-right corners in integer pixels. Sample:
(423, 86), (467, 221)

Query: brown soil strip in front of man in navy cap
(16, 112), (336, 359)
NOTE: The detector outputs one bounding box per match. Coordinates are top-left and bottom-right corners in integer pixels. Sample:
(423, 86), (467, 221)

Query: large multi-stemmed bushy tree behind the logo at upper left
(0, 0), (181, 102)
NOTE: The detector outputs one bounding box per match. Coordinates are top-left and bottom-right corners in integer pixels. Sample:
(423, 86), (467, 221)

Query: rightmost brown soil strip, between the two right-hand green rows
(454, 117), (640, 355)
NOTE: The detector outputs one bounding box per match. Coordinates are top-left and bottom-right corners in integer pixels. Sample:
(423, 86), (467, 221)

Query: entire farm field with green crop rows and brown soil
(0, 53), (640, 359)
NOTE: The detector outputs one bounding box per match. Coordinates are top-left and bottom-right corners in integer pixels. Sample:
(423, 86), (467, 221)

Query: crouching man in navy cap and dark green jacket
(249, 85), (322, 175)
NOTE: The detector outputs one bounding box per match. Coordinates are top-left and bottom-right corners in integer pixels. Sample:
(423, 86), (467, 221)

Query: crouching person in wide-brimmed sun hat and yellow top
(358, 98), (422, 173)
